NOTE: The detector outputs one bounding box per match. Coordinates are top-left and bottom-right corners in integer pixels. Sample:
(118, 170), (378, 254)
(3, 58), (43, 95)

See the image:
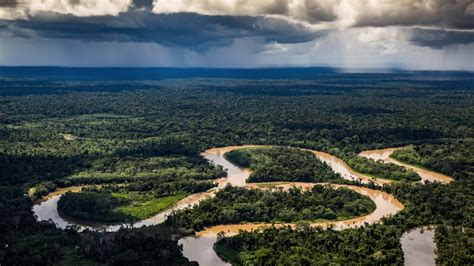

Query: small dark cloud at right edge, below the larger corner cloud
(410, 28), (474, 49)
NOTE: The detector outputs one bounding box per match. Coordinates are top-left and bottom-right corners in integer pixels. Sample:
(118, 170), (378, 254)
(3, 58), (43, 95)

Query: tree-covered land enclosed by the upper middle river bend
(224, 147), (341, 182)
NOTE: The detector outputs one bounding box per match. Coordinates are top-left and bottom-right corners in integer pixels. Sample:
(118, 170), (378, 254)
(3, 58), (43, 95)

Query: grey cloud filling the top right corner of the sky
(355, 0), (474, 29)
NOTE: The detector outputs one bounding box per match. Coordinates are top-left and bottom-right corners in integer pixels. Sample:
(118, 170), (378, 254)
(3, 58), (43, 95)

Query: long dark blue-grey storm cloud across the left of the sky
(0, 9), (323, 50)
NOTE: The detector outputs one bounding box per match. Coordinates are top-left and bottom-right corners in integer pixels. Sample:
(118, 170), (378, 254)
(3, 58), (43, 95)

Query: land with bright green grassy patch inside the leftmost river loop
(58, 178), (215, 223)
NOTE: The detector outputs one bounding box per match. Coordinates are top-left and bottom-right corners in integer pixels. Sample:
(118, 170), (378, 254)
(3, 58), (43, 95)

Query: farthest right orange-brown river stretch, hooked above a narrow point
(359, 148), (453, 183)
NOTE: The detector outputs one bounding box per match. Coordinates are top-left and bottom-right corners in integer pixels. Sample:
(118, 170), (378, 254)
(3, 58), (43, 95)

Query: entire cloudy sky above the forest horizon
(0, 0), (474, 71)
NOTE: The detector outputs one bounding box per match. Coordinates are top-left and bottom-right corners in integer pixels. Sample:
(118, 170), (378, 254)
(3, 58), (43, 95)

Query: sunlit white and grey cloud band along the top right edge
(153, 0), (474, 29)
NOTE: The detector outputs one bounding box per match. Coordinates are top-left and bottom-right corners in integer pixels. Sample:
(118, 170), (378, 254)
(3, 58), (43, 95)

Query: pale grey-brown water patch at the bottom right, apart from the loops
(400, 227), (436, 266)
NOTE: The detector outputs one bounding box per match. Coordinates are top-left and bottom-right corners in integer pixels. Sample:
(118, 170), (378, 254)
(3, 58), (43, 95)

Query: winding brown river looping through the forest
(33, 145), (452, 265)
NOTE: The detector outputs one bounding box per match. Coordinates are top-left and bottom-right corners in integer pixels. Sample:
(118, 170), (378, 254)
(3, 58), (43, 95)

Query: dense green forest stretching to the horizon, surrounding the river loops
(0, 72), (474, 265)
